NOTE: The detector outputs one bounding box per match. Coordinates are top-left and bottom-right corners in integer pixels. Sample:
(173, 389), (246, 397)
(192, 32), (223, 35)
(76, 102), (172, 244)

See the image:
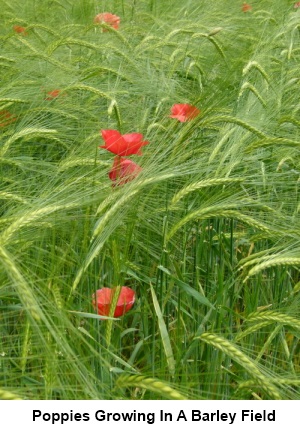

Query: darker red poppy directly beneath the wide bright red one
(108, 156), (142, 186)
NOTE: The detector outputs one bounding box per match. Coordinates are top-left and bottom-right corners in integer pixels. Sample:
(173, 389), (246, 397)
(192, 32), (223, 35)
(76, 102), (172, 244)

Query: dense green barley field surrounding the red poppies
(0, 0), (300, 399)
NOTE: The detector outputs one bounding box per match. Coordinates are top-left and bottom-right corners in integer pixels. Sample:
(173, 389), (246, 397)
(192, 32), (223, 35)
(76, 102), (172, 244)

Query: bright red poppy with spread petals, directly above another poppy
(100, 130), (149, 156)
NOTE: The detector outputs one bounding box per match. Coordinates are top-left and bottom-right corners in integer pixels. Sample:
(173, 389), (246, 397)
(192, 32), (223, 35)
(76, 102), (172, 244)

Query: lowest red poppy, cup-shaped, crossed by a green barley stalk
(93, 287), (135, 317)
